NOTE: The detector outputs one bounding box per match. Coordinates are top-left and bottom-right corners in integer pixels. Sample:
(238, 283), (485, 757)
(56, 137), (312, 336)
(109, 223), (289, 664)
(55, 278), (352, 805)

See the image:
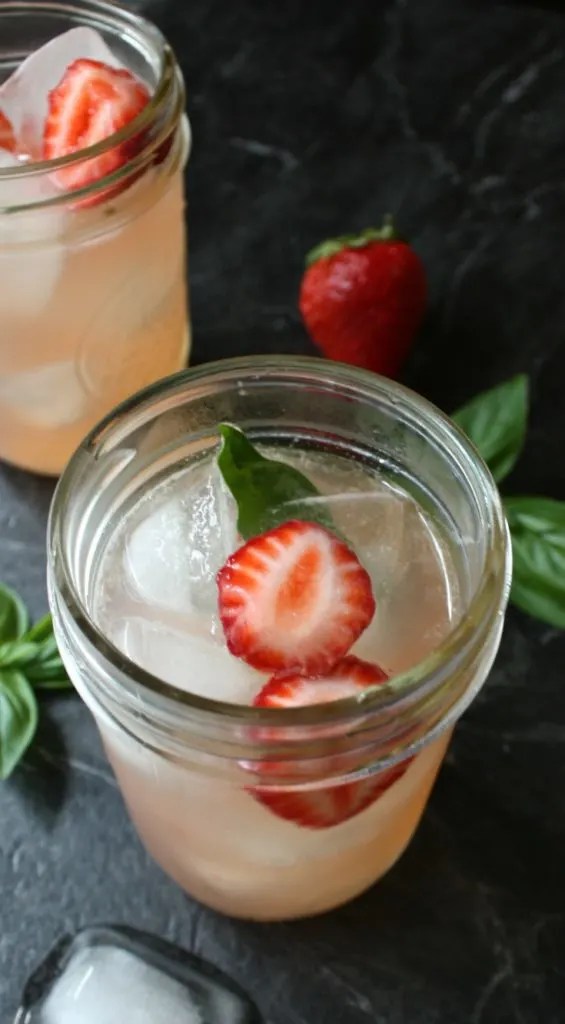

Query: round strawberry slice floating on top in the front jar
(217, 519), (375, 676)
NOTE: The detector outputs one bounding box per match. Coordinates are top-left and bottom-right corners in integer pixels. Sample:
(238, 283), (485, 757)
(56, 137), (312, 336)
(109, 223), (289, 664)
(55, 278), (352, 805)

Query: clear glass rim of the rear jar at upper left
(0, 0), (187, 207)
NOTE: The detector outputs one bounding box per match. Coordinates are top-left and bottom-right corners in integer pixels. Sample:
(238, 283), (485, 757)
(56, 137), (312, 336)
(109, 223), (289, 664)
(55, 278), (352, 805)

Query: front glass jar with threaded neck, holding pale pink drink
(48, 356), (511, 920)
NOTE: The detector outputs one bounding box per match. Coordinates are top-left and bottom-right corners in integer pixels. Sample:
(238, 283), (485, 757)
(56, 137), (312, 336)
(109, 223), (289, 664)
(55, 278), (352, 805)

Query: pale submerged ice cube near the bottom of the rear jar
(0, 362), (90, 430)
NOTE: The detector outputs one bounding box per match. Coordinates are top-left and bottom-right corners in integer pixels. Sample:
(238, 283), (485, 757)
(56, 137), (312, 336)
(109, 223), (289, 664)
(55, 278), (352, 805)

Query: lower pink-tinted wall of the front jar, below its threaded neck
(100, 724), (450, 921)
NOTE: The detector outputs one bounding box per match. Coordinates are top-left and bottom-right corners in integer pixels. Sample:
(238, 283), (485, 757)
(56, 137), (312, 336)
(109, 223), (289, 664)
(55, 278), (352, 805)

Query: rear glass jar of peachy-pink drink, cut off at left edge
(0, 0), (190, 474)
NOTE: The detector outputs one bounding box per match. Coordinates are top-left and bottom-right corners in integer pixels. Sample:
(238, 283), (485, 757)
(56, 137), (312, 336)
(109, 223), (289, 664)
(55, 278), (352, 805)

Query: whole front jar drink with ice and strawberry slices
(49, 357), (510, 920)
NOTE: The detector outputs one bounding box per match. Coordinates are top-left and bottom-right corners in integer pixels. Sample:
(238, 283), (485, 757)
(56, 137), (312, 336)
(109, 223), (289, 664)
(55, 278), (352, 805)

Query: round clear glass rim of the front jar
(48, 355), (511, 727)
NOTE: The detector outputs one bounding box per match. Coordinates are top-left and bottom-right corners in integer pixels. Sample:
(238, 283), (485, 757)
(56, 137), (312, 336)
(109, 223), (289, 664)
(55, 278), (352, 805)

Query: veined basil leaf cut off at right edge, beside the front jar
(505, 498), (565, 629)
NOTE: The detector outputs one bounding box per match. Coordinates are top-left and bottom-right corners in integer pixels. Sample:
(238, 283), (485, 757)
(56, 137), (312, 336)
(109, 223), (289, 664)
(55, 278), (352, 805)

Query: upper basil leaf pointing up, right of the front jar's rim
(451, 374), (528, 483)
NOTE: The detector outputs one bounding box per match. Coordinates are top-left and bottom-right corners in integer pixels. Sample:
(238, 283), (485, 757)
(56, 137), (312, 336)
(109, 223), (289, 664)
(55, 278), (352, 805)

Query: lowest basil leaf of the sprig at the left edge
(0, 670), (38, 779)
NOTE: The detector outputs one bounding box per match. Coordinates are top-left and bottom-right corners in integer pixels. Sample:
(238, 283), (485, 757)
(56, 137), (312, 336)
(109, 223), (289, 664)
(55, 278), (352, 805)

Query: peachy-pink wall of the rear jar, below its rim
(0, 167), (190, 474)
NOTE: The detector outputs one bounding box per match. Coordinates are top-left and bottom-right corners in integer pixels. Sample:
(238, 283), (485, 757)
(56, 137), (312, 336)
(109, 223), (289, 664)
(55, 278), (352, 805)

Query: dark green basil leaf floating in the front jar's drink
(218, 423), (336, 541)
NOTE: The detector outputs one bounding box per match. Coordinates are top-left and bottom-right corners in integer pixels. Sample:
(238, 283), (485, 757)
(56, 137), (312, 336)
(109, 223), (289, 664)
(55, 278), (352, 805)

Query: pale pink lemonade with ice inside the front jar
(89, 455), (460, 919)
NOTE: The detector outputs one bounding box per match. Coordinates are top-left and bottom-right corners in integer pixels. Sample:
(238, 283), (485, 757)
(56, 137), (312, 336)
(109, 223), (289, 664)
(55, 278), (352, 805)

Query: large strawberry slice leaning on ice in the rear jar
(43, 59), (149, 190)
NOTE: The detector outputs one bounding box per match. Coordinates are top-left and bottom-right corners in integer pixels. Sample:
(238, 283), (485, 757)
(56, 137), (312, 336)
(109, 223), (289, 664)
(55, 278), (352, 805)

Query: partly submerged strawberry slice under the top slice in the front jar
(249, 654), (411, 828)
